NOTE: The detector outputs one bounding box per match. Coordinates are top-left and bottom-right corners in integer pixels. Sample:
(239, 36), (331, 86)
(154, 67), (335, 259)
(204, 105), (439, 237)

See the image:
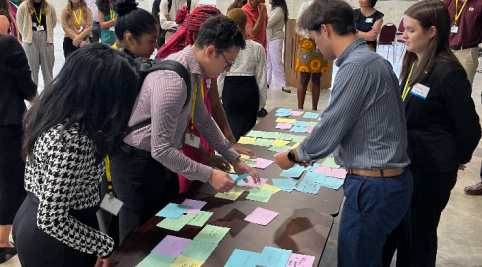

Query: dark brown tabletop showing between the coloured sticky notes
(114, 108), (343, 267)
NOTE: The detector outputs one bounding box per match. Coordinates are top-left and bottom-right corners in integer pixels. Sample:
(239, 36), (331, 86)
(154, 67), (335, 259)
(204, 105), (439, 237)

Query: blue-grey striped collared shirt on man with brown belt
(296, 38), (410, 170)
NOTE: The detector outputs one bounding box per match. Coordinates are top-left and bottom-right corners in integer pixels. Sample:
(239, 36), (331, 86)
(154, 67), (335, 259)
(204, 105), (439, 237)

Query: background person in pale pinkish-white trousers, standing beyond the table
(266, 0), (291, 93)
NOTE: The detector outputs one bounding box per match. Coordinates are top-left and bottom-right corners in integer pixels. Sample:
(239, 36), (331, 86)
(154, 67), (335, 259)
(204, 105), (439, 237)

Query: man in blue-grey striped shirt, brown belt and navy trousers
(276, 0), (412, 267)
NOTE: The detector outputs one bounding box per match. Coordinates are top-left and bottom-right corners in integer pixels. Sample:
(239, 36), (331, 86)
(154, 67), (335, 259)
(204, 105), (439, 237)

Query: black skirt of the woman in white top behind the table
(222, 76), (259, 141)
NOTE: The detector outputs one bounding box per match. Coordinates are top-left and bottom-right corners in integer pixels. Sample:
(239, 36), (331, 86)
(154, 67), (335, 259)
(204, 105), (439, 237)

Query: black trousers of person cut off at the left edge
(0, 125), (27, 225)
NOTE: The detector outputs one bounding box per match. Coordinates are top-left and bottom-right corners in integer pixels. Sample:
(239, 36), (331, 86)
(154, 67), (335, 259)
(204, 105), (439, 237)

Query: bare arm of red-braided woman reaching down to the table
(208, 80), (258, 158)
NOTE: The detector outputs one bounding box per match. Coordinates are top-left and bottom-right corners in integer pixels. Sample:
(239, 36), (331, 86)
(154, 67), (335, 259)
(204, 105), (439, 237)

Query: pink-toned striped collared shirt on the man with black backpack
(124, 46), (240, 182)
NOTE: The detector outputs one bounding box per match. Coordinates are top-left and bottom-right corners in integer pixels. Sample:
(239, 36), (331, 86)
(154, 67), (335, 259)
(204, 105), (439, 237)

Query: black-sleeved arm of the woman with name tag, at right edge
(439, 68), (481, 164)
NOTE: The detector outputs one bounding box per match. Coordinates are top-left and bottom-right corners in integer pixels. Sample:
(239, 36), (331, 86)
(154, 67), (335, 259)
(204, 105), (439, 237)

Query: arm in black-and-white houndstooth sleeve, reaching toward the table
(37, 132), (114, 258)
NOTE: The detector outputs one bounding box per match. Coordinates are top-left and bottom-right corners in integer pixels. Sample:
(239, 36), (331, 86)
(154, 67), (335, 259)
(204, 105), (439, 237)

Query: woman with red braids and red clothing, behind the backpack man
(156, 5), (255, 193)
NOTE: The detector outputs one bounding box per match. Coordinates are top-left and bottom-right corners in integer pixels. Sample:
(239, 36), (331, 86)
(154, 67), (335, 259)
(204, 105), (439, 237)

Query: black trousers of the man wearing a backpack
(110, 148), (179, 244)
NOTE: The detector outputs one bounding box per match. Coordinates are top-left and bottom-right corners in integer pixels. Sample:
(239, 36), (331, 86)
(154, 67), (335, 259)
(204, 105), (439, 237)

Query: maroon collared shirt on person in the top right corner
(444, 0), (482, 46)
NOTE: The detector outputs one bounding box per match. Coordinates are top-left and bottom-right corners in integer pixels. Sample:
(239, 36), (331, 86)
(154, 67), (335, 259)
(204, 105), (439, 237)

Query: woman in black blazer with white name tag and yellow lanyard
(383, 0), (481, 267)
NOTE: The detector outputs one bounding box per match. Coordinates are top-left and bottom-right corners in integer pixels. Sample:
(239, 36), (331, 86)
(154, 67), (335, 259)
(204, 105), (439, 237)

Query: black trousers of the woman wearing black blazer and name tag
(382, 169), (457, 267)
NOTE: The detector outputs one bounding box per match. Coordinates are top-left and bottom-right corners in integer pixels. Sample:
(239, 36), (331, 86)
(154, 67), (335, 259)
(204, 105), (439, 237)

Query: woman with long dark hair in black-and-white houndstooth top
(13, 43), (139, 267)
